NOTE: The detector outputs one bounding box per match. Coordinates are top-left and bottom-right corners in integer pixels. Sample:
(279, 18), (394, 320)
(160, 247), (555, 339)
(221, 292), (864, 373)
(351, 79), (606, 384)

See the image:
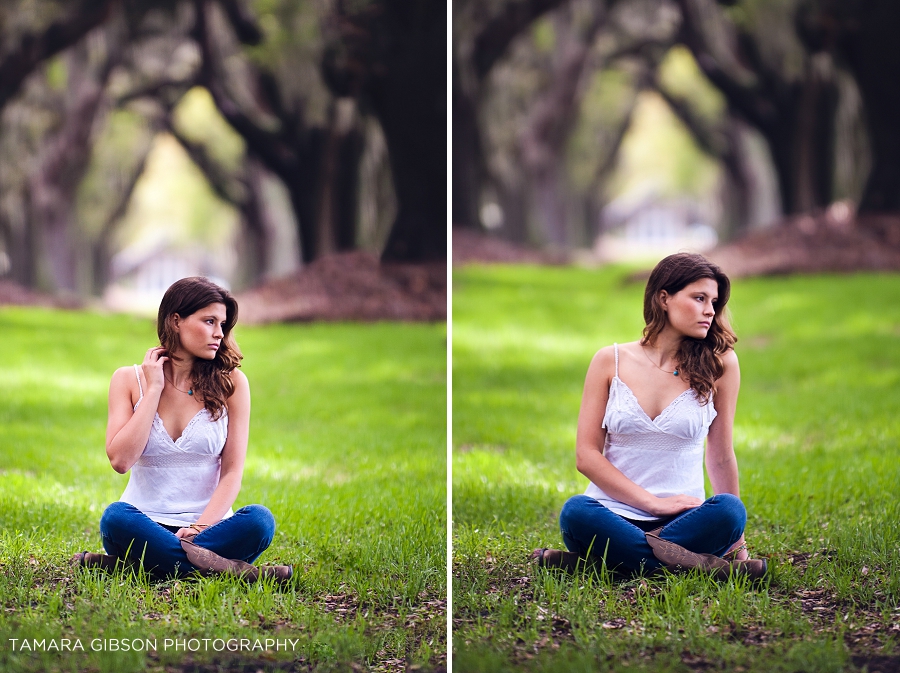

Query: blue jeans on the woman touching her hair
(100, 502), (275, 579)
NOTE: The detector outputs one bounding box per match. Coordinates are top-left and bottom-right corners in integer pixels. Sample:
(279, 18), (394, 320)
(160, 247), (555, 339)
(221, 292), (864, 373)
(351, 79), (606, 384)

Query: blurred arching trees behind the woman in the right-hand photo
(452, 0), (900, 255)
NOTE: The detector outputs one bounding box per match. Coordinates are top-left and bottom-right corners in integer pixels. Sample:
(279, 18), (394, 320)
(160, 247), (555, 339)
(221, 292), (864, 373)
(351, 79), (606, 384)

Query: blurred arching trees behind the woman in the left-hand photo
(0, 0), (447, 296)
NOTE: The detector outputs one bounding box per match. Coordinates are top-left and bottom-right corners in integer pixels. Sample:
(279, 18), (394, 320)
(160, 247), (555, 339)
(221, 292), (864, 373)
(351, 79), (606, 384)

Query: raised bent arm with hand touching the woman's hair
(106, 347), (168, 474)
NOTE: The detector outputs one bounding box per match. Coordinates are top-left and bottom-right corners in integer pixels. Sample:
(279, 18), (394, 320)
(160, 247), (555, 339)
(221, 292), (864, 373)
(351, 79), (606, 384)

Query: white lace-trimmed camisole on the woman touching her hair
(120, 365), (233, 527)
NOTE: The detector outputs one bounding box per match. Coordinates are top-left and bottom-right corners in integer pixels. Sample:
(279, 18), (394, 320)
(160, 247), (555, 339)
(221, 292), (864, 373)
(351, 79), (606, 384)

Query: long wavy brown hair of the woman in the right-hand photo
(641, 252), (737, 404)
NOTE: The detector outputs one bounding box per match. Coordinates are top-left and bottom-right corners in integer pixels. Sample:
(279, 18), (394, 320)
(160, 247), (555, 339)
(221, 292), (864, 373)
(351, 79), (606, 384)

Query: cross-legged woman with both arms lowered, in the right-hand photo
(532, 253), (766, 577)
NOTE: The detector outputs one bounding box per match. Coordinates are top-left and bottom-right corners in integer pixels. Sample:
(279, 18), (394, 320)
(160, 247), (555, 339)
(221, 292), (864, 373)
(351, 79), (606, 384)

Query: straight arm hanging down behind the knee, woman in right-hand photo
(706, 350), (741, 497)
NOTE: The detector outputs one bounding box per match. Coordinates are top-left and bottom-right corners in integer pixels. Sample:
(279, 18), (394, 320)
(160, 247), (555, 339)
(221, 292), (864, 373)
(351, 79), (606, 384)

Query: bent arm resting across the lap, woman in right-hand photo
(575, 346), (702, 516)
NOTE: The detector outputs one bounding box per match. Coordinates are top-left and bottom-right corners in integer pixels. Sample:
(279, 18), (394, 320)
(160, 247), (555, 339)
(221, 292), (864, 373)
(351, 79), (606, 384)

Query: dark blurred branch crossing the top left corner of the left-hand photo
(0, 0), (116, 109)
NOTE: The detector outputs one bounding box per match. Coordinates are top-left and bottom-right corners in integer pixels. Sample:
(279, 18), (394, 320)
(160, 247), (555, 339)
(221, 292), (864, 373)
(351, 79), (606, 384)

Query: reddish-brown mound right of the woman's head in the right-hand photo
(707, 206), (900, 277)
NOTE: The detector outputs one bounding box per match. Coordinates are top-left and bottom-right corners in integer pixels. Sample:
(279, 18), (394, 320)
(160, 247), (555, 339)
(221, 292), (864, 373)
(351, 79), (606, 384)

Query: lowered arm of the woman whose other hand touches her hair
(176, 369), (250, 538)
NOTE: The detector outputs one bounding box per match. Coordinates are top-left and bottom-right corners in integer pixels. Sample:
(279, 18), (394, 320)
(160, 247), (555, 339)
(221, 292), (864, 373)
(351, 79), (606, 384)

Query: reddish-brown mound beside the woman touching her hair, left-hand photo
(237, 252), (447, 324)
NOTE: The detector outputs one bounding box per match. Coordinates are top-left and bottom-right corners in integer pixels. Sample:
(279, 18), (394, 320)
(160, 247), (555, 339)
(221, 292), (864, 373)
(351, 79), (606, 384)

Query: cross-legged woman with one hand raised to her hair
(73, 278), (292, 581)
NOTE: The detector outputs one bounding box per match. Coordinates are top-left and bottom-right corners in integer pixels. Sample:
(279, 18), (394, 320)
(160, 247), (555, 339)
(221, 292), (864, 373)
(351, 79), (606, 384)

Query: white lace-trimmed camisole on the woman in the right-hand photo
(584, 344), (716, 521)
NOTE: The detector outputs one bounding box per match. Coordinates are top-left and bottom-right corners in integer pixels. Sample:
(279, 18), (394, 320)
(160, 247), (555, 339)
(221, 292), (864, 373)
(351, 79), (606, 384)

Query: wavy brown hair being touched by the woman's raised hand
(156, 276), (244, 421)
